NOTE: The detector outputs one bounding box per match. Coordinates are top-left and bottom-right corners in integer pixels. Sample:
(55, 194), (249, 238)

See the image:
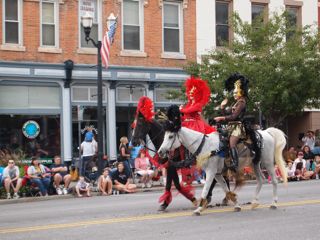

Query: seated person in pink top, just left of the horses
(135, 149), (154, 188)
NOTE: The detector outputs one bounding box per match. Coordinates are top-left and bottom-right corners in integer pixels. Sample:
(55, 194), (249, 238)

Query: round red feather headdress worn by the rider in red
(185, 76), (211, 106)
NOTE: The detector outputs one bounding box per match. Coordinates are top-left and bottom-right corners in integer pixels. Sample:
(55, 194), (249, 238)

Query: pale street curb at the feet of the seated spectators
(0, 180), (256, 205)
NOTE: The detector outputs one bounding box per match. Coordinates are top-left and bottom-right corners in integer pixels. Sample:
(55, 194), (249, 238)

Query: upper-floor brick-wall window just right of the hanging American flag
(122, 0), (143, 51)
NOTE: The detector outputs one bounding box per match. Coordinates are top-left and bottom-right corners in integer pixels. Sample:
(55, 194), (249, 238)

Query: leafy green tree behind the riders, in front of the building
(185, 13), (320, 126)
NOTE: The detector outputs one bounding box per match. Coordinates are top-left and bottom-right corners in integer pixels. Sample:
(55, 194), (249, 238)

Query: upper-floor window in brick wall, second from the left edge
(40, 0), (59, 47)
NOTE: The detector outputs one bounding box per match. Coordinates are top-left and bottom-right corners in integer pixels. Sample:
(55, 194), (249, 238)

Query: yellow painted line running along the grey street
(0, 200), (320, 234)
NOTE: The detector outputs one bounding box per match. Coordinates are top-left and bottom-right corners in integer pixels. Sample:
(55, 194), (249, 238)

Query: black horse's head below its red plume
(131, 112), (151, 146)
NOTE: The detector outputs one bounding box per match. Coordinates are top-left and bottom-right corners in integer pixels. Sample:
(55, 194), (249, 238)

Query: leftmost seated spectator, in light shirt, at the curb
(3, 159), (22, 199)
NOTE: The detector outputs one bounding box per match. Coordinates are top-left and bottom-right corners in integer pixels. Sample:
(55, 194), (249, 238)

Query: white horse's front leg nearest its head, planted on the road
(194, 159), (217, 216)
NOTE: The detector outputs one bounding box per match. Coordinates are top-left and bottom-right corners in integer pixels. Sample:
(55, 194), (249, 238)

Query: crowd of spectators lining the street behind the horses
(0, 130), (320, 199)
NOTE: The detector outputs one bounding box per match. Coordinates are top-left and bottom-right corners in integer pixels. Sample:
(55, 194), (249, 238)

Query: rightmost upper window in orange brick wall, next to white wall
(162, 2), (183, 53)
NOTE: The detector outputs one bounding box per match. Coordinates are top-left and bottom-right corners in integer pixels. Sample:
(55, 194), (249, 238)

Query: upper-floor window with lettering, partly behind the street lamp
(79, 0), (101, 48)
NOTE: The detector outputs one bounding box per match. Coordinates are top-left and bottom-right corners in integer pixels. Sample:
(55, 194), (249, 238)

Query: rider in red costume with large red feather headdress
(180, 77), (216, 134)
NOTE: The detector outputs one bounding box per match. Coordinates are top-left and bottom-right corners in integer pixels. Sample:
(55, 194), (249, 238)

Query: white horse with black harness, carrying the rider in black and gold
(158, 127), (287, 215)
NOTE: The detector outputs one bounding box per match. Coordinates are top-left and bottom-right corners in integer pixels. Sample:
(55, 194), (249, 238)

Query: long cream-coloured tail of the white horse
(266, 127), (288, 184)
